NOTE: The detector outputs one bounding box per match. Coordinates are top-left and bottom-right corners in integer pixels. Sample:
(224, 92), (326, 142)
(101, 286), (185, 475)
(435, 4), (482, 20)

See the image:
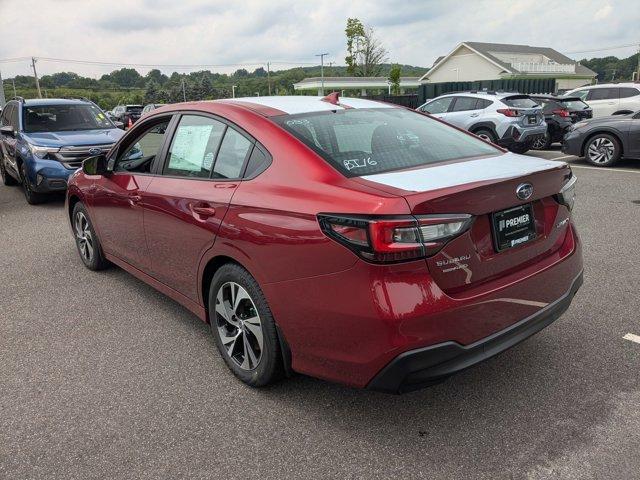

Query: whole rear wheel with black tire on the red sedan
(209, 263), (284, 387)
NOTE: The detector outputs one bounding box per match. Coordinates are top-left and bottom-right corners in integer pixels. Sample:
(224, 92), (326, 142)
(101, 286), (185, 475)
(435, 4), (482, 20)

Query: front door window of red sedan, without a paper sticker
(114, 119), (169, 173)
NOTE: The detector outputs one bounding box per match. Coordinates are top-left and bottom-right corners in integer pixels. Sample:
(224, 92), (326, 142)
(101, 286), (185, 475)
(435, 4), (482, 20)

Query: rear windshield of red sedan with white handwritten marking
(274, 108), (501, 177)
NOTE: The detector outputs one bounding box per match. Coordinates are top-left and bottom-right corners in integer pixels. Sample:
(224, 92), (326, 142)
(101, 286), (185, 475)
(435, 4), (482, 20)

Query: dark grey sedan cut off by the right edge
(562, 111), (640, 167)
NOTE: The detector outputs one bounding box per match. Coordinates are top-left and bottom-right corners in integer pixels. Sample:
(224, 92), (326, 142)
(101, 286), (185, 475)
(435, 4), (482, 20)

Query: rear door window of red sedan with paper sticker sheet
(163, 115), (226, 178)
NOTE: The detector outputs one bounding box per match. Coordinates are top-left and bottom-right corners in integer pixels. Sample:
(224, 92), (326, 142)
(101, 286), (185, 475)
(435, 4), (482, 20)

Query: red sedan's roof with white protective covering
(213, 95), (400, 117)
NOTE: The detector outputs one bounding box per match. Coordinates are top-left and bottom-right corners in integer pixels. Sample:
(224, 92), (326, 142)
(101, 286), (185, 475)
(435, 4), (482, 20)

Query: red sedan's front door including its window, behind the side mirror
(91, 117), (170, 271)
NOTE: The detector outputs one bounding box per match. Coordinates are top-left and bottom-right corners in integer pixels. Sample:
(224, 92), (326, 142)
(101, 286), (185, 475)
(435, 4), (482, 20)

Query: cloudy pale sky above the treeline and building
(0, 0), (640, 78)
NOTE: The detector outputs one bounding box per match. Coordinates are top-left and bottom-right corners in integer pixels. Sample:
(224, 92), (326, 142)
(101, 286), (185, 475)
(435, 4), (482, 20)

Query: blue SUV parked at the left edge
(0, 97), (124, 205)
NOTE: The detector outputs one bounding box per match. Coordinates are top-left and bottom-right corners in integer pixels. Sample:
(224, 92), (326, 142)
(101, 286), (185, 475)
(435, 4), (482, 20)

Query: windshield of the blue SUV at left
(23, 103), (115, 132)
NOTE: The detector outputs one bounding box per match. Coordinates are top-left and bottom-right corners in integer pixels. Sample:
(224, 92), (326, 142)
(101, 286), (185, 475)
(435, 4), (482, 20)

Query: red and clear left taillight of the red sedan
(318, 214), (473, 263)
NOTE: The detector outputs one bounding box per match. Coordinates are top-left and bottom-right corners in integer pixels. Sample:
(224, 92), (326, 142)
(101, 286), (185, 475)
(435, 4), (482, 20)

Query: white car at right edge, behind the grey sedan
(565, 83), (640, 118)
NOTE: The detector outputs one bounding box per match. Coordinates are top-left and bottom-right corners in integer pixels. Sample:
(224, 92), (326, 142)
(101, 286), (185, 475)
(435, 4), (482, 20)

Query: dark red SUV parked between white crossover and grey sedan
(531, 95), (593, 150)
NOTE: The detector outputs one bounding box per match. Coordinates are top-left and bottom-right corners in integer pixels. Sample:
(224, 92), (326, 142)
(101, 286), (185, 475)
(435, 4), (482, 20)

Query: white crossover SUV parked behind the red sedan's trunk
(418, 91), (547, 153)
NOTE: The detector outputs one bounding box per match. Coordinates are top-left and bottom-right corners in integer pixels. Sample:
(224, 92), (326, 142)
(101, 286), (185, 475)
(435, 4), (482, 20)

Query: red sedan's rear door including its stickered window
(143, 113), (254, 301)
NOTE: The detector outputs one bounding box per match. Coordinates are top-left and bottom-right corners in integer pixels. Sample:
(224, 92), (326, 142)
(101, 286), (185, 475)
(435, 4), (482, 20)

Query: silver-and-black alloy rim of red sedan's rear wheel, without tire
(215, 282), (264, 370)
